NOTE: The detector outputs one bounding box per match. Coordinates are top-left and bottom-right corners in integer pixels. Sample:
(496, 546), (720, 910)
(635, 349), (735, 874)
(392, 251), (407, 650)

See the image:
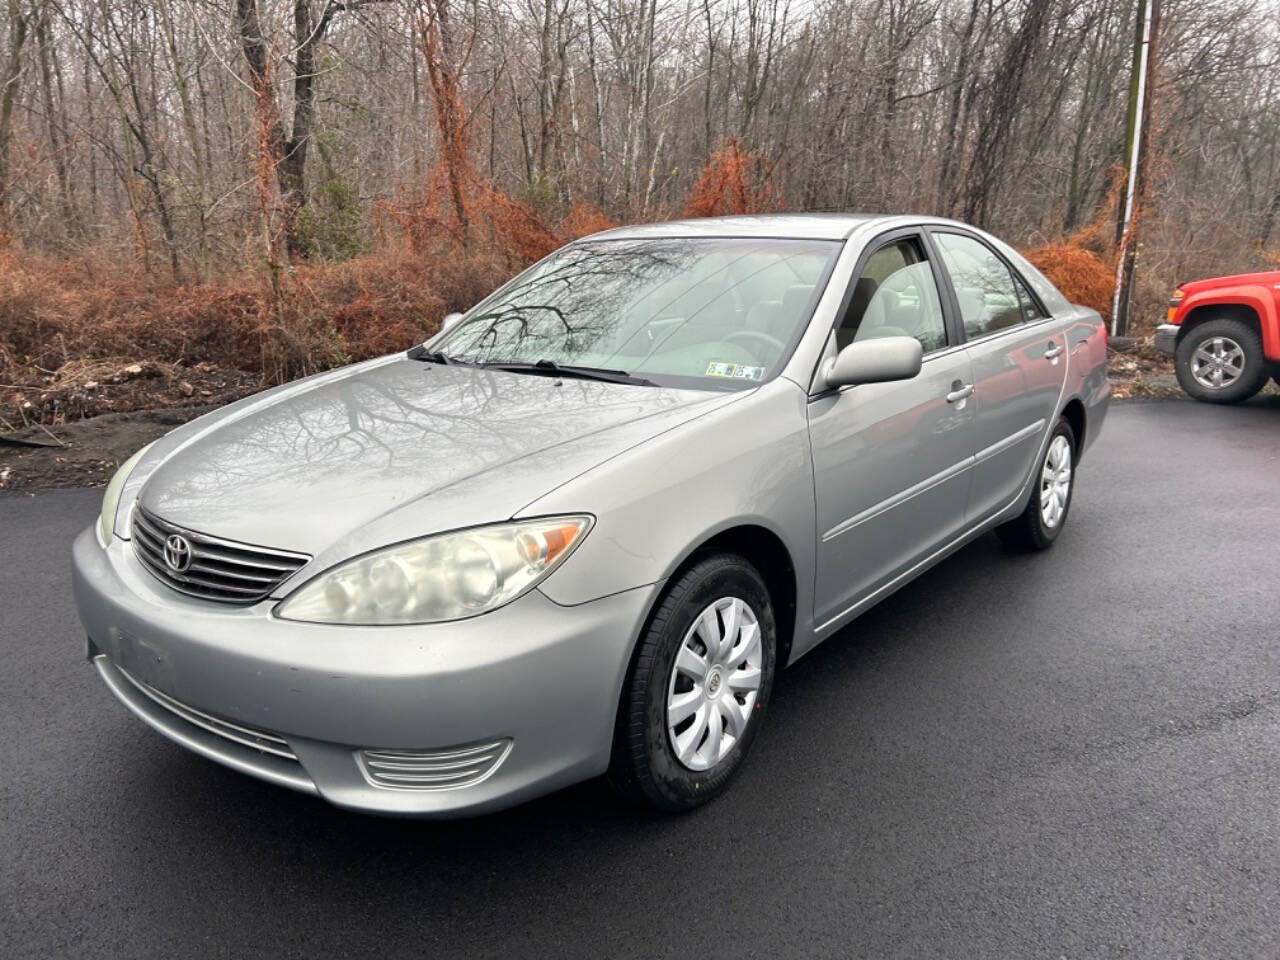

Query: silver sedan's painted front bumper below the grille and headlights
(72, 529), (658, 817)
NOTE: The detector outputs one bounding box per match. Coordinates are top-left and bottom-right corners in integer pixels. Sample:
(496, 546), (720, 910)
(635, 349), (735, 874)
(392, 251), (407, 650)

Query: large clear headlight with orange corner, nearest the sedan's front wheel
(275, 516), (591, 625)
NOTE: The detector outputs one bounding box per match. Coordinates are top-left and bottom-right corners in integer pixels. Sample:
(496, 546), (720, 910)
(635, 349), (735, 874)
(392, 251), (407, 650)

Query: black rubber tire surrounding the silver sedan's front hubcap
(608, 553), (777, 813)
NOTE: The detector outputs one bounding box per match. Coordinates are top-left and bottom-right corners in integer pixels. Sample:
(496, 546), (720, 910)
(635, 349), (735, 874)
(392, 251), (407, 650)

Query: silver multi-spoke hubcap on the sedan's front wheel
(667, 596), (763, 771)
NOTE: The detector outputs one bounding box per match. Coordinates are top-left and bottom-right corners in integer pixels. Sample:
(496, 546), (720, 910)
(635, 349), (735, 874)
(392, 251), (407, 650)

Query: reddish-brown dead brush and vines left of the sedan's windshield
(0, 180), (624, 428)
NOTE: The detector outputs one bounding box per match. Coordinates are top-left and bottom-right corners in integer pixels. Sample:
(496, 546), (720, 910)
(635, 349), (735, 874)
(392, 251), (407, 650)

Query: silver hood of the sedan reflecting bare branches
(140, 358), (742, 559)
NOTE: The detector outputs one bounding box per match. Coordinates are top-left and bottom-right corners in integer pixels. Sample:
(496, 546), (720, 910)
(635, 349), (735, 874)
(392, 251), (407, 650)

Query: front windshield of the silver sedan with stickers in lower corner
(431, 238), (840, 387)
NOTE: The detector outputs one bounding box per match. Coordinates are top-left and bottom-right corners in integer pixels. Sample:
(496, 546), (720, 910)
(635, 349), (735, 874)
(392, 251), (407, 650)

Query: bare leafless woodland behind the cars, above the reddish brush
(0, 0), (1280, 321)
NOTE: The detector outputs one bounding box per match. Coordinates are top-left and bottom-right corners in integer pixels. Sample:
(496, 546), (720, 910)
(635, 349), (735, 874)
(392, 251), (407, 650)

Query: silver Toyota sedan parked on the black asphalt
(74, 215), (1110, 815)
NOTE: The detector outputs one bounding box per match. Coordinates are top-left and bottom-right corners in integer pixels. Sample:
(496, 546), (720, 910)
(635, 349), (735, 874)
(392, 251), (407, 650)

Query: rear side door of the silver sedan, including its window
(929, 227), (1066, 524)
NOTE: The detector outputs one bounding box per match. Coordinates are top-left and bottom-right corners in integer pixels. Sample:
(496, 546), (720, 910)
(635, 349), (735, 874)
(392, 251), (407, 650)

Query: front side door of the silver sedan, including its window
(809, 232), (974, 631)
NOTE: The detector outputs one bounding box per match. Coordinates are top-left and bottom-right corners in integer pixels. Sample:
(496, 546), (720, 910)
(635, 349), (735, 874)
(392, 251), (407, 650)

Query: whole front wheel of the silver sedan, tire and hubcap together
(609, 553), (777, 812)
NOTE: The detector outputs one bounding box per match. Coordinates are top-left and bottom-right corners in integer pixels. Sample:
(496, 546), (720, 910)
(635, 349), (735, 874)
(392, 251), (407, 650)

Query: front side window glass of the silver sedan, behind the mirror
(836, 239), (947, 353)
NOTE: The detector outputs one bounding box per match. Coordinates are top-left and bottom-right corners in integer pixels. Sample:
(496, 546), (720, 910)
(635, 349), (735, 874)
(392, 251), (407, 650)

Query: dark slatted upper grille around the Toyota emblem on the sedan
(133, 506), (311, 603)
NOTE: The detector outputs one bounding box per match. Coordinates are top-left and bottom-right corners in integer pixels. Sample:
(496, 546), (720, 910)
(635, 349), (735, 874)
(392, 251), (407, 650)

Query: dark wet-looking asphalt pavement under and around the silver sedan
(0, 397), (1280, 959)
